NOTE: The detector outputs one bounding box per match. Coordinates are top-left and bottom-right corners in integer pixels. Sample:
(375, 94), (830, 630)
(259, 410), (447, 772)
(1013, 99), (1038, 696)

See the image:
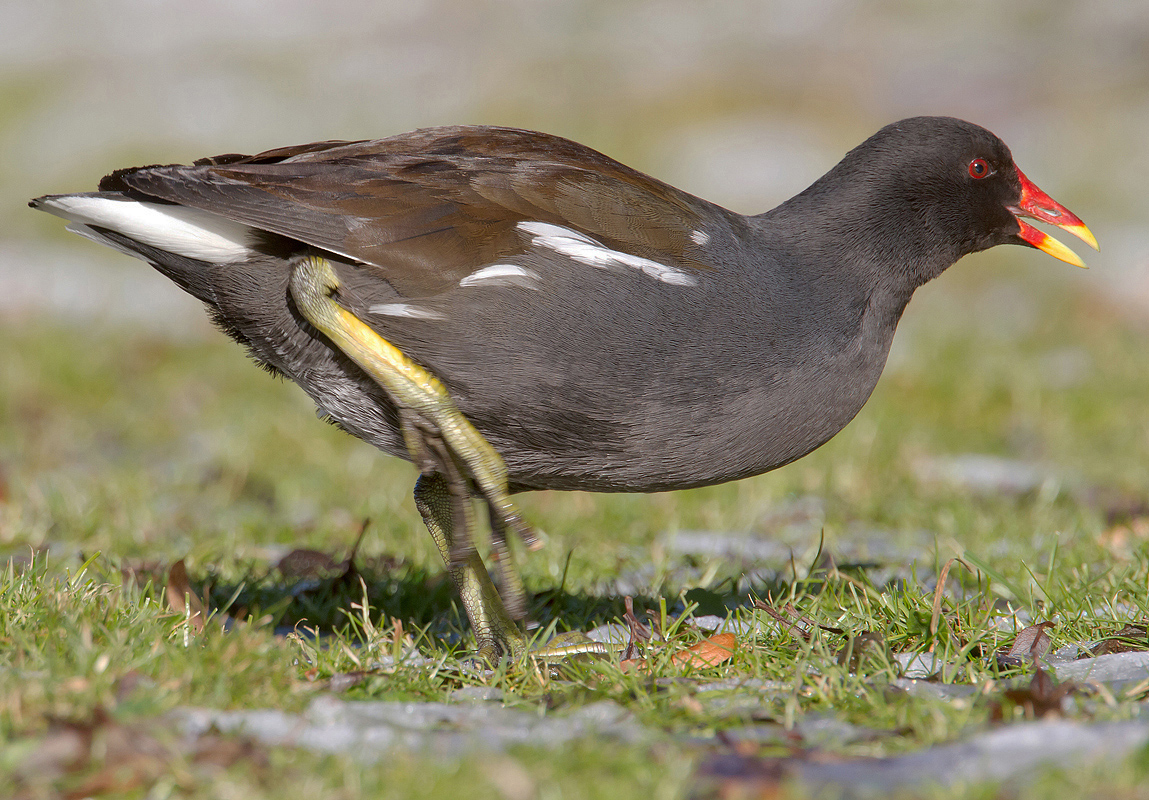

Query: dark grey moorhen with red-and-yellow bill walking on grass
(30, 116), (1097, 661)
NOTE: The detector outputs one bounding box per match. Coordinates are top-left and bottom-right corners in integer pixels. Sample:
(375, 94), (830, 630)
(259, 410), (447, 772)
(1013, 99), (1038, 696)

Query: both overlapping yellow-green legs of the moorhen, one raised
(291, 255), (533, 659)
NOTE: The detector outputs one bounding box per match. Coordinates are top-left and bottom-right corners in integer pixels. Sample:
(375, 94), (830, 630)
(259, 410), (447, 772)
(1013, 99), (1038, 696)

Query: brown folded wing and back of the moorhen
(100, 126), (735, 297)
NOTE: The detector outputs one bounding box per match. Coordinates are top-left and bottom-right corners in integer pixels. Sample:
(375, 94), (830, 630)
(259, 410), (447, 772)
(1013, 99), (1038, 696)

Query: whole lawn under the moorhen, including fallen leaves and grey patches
(0, 248), (1149, 799)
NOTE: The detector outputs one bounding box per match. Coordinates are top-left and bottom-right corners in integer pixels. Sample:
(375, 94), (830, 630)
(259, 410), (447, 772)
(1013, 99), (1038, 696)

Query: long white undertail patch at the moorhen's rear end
(40, 194), (252, 263)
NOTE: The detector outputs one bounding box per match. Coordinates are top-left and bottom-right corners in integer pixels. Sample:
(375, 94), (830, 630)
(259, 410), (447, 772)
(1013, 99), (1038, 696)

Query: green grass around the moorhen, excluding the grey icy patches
(0, 259), (1149, 798)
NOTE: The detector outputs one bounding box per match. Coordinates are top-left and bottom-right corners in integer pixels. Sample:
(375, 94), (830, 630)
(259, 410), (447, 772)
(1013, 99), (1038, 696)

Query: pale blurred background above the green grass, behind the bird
(0, 0), (1149, 333)
